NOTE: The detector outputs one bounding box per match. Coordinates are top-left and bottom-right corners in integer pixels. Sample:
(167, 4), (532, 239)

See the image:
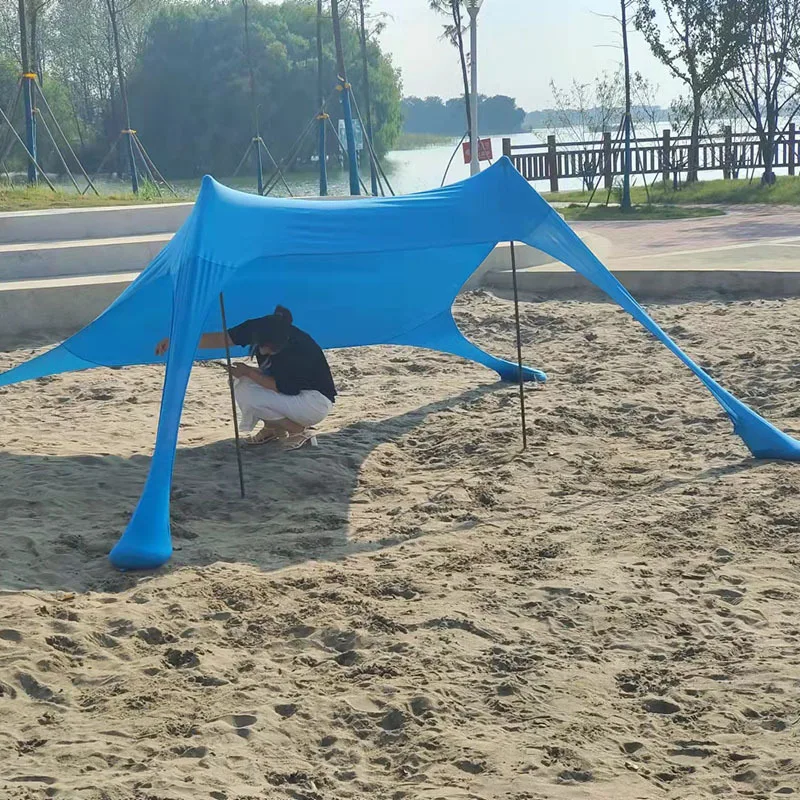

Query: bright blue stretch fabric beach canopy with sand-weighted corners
(0, 157), (800, 569)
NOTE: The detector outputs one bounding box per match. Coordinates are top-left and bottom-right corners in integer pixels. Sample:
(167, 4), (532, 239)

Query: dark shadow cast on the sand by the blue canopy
(0, 383), (503, 592)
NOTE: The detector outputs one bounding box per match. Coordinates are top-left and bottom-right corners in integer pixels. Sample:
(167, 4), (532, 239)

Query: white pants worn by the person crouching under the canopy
(234, 378), (333, 433)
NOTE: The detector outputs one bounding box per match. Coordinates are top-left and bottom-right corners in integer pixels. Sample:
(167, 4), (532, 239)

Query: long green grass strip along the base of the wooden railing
(544, 175), (800, 206)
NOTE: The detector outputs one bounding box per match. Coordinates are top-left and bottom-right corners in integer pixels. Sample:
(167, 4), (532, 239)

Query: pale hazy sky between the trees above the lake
(373, 0), (681, 111)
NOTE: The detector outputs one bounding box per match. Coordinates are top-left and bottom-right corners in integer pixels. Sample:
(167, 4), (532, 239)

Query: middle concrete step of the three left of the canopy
(0, 233), (172, 281)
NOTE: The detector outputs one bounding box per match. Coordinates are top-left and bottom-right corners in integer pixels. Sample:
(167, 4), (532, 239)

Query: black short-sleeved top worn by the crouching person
(228, 319), (336, 403)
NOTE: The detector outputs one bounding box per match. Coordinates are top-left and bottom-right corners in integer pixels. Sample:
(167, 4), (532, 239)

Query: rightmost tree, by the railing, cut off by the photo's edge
(726, 0), (800, 184)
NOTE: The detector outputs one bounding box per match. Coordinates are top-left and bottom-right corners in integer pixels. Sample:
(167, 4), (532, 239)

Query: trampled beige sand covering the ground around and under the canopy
(0, 295), (800, 800)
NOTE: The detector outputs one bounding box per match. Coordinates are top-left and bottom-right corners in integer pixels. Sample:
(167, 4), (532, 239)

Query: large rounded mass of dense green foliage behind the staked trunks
(129, 0), (401, 176)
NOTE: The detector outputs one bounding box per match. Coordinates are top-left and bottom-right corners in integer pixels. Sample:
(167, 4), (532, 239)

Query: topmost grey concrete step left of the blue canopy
(0, 203), (194, 244)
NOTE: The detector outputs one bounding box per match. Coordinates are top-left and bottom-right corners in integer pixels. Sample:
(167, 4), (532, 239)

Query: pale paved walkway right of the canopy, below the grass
(574, 206), (800, 271)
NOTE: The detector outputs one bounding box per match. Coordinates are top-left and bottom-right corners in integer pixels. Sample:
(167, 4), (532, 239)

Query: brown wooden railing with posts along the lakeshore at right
(503, 122), (800, 192)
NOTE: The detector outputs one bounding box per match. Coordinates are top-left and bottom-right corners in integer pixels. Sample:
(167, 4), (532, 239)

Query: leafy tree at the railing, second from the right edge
(635, 0), (748, 182)
